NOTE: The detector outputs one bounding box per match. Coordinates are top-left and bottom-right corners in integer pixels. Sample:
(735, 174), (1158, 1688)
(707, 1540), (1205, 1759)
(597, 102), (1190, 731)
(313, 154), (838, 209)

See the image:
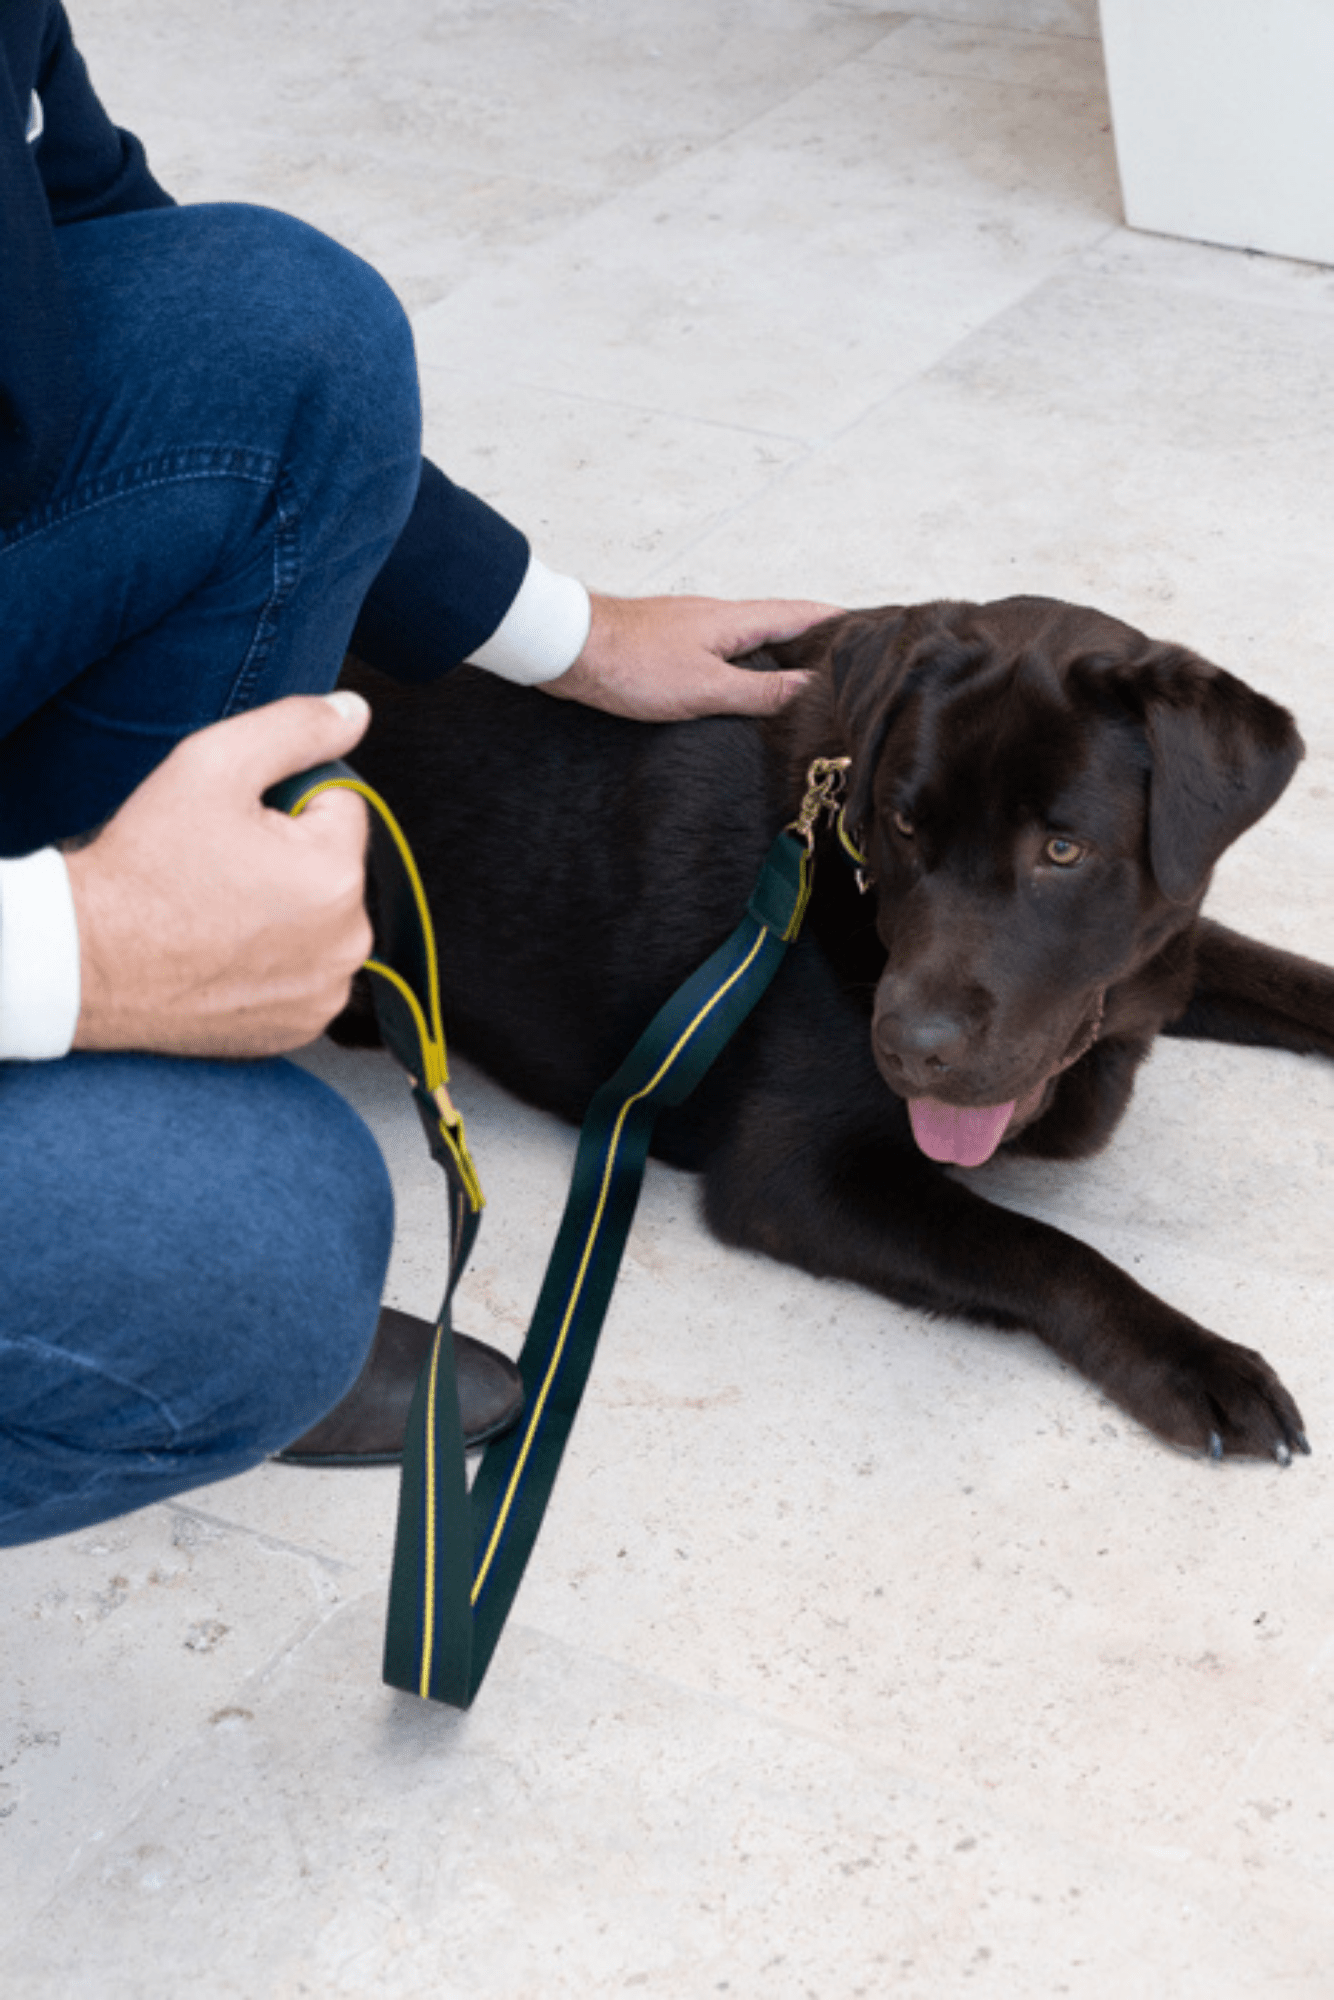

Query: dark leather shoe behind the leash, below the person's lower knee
(276, 1306), (524, 1466)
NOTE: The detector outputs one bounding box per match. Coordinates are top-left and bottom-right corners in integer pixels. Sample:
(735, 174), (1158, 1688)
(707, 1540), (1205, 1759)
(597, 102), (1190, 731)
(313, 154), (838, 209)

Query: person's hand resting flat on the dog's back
(542, 592), (838, 722)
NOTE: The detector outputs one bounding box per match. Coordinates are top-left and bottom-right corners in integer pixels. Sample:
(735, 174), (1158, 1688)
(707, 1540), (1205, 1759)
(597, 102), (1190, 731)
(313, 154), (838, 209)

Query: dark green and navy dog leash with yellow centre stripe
(266, 758), (850, 1708)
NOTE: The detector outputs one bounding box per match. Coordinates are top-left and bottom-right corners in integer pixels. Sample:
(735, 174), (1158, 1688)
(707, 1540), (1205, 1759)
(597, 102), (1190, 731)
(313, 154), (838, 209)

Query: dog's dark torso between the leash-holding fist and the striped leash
(346, 662), (784, 1120)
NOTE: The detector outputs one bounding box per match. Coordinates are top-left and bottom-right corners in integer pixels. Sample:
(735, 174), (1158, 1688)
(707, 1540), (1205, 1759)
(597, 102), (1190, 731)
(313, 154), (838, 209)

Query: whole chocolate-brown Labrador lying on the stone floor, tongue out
(342, 598), (1334, 1464)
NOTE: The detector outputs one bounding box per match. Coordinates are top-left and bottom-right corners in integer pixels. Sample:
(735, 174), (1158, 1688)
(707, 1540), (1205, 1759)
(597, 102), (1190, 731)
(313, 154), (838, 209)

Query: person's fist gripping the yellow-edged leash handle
(66, 692), (372, 1056)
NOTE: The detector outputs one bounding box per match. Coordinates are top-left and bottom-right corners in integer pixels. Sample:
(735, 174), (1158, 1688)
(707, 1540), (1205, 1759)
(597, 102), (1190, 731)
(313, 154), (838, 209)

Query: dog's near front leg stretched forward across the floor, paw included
(706, 1098), (1308, 1464)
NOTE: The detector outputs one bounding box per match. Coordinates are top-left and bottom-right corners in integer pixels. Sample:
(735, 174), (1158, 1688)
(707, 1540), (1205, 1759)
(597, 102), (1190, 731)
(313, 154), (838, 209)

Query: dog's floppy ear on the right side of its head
(1140, 650), (1302, 902)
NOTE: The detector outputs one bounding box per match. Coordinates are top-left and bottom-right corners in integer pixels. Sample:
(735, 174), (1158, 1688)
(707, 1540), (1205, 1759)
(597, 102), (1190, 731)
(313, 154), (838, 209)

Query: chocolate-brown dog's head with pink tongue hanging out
(778, 598), (1302, 1166)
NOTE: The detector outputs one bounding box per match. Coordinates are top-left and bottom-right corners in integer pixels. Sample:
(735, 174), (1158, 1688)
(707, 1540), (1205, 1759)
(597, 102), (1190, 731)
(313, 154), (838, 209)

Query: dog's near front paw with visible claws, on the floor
(1132, 1328), (1310, 1466)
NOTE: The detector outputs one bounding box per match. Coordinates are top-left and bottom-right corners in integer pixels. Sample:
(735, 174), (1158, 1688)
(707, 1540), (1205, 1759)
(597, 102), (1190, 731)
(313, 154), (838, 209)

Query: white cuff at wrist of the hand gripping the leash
(0, 848), (80, 1062)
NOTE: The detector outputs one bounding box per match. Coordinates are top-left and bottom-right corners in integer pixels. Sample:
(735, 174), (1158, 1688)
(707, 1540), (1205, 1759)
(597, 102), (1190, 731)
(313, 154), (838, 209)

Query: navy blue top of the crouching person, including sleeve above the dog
(0, 0), (528, 680)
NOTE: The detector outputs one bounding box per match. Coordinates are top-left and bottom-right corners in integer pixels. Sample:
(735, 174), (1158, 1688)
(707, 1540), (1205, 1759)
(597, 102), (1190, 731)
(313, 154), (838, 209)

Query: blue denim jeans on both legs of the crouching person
(0, 206), (420, 1544)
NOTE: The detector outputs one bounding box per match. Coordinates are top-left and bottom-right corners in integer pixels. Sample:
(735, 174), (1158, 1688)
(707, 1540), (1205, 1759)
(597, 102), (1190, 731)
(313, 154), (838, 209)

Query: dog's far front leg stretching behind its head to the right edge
(1164, 918), (1334, 1056)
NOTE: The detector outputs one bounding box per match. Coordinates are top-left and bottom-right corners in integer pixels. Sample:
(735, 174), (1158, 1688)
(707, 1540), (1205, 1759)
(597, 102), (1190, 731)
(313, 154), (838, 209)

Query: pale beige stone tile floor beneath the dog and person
(0, 0), (1334, 2000)
